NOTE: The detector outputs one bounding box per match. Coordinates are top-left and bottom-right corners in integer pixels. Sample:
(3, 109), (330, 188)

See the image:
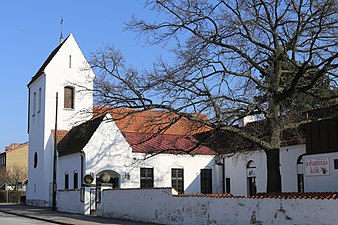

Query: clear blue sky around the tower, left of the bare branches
(0, 0), (163, 152)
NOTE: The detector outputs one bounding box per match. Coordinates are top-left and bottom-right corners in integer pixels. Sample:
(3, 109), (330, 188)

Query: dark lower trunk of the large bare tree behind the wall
(265, 149), (282, 193)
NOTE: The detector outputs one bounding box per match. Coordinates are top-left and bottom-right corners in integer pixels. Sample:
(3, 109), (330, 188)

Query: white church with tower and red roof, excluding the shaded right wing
(26, 34), (222, 206)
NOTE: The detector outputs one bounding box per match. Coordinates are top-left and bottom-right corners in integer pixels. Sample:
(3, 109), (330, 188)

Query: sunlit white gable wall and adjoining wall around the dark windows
(84, 114), (219, 193)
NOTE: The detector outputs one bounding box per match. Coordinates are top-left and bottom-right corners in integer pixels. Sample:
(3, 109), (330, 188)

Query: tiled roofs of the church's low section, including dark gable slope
(52, 109), (217, 156)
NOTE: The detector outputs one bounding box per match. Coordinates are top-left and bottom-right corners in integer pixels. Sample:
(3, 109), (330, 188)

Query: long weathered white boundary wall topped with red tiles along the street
(97, 188), (338, 225)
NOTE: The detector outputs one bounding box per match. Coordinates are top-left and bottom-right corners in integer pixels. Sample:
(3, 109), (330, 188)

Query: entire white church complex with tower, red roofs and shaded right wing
(26, 34), (338, 213)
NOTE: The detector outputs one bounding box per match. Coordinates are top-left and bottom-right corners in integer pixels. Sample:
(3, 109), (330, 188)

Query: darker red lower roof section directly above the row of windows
(122, 132), (217, 155)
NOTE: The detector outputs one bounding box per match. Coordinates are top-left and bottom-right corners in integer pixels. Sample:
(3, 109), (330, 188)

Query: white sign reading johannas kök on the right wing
(304, 158), (330, 176)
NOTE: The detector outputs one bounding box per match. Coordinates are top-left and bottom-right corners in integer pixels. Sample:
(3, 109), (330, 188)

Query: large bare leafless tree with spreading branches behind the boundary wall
(91, 0), (338, 192)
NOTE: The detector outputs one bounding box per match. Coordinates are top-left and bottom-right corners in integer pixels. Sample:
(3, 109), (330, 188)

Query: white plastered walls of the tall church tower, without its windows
(27, 35), (94, 205)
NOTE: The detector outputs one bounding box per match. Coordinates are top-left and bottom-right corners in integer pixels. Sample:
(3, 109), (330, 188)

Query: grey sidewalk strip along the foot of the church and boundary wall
(0, 204), (159, 225)
